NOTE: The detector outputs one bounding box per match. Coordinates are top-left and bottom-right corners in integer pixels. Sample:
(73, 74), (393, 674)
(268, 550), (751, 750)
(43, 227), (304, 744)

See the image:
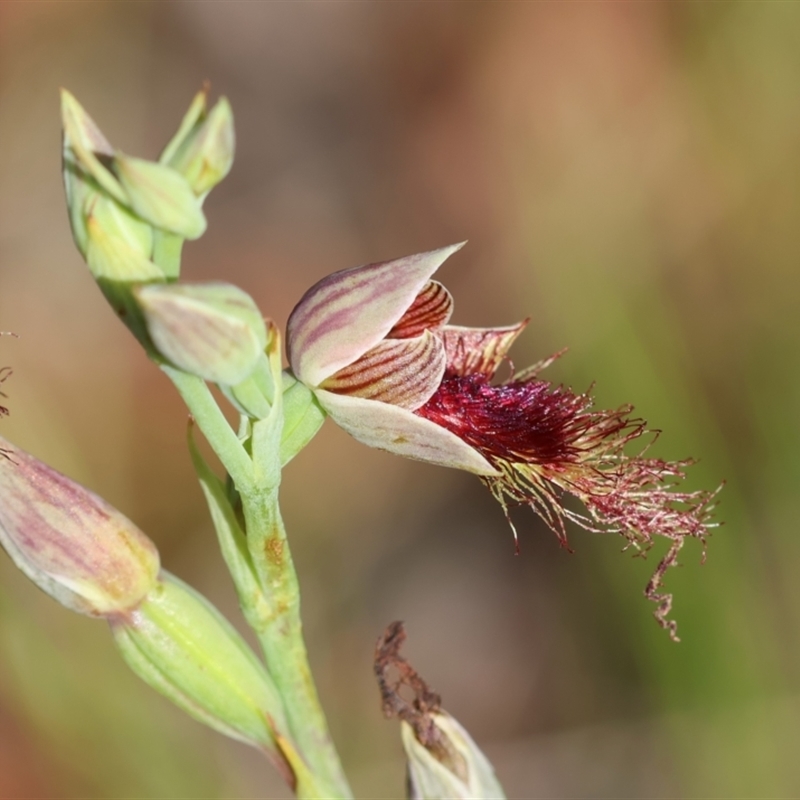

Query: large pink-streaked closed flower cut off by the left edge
(0, 438), (159, 617)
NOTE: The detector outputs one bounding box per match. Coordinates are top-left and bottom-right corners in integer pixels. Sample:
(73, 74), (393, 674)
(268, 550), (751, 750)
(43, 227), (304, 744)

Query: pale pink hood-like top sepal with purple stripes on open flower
(286, 243), (463, 387)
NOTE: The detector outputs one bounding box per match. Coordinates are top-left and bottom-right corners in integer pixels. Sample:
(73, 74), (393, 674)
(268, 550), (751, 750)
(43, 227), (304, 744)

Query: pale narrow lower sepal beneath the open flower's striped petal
(315, 389), (500, 476)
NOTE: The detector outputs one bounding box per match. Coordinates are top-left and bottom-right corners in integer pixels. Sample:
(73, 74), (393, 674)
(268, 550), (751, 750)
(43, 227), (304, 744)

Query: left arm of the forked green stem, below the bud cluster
(159, 364), (253, 487)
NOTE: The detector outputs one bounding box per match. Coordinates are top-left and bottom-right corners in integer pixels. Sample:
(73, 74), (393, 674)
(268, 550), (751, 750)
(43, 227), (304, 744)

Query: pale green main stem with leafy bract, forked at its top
(170, 366), (352, 798)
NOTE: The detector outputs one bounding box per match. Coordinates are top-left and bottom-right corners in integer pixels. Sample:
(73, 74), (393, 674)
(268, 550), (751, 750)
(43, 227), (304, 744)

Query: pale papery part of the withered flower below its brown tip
(400, 712), (505, 800)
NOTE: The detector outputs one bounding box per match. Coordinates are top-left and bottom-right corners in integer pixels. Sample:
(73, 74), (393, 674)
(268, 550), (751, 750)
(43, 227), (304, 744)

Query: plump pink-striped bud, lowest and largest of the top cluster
(135, 283), (267, 386)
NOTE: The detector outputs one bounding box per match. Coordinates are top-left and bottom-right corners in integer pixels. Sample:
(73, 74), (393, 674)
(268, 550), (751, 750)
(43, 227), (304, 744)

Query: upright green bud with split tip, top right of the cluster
(159, 89), (235, 198)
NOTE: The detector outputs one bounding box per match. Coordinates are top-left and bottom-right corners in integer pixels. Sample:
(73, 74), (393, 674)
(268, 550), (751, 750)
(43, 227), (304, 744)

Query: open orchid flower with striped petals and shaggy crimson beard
(287, 244), (716, 638)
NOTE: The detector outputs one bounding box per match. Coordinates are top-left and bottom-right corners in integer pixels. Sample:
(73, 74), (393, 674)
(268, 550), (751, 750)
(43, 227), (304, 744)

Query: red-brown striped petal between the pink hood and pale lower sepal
(320, 331), (445, 411)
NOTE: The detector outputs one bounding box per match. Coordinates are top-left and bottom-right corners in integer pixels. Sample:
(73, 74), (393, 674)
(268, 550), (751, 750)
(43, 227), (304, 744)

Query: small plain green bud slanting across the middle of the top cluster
(113, 152), (206, 239)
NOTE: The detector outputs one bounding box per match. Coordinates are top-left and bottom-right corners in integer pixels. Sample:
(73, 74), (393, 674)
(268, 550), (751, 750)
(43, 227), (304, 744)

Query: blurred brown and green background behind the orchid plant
(0, 0), (800, 798)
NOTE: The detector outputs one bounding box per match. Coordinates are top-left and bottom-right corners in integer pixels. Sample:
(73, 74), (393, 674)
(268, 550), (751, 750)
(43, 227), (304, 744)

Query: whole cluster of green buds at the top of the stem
(61, 89), (276, 400)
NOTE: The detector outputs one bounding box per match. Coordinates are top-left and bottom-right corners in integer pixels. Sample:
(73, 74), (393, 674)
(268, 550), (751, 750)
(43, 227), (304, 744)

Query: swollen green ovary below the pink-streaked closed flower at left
(112, 573), (286, 757)
